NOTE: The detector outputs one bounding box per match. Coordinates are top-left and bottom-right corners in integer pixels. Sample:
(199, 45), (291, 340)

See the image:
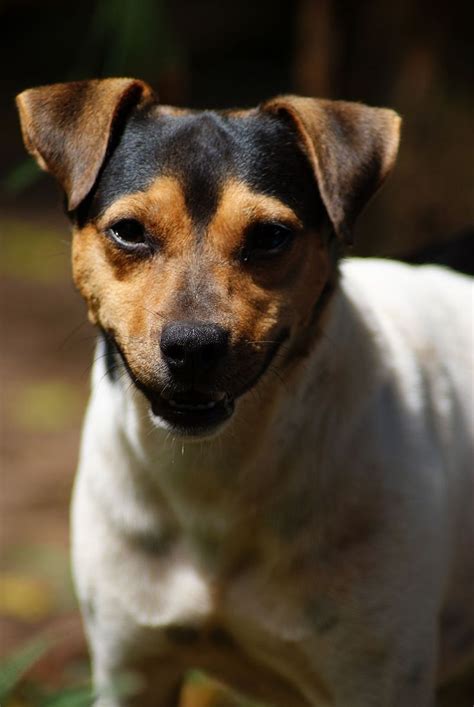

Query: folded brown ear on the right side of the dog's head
(260, 96), (401, 243)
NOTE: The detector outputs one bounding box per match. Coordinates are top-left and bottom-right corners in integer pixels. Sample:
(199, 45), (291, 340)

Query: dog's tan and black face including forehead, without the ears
(73, 106), (330, 432)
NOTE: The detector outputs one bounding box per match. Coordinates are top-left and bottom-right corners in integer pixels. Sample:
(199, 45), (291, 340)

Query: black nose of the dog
(160, 321), (229, 378)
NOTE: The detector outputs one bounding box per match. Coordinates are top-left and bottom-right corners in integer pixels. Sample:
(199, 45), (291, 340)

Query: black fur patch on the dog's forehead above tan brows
(86, 106), (318, 225)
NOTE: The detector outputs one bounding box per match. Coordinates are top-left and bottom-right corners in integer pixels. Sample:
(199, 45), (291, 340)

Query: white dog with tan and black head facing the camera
(17, 78), (474, 707)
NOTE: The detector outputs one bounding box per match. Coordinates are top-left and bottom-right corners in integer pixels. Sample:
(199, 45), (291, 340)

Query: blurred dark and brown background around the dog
(0, 0), (474, 707)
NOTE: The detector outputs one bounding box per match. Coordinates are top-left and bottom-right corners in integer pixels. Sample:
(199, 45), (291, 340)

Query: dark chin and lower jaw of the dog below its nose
(143, 390), (235, 439)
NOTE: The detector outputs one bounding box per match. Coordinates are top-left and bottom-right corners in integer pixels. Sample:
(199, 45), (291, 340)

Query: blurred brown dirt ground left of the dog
(0, 203), (94, 683)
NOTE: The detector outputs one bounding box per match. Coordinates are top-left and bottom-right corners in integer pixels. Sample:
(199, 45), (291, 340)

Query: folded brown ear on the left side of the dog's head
(16, 79), (153, 211)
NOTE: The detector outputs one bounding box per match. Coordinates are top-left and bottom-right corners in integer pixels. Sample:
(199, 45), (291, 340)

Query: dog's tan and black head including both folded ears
(17, 79), (400, 435)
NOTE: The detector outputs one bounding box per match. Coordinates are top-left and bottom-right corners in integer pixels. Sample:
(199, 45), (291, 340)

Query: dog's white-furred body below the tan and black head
(72, 259), (474, 707)
